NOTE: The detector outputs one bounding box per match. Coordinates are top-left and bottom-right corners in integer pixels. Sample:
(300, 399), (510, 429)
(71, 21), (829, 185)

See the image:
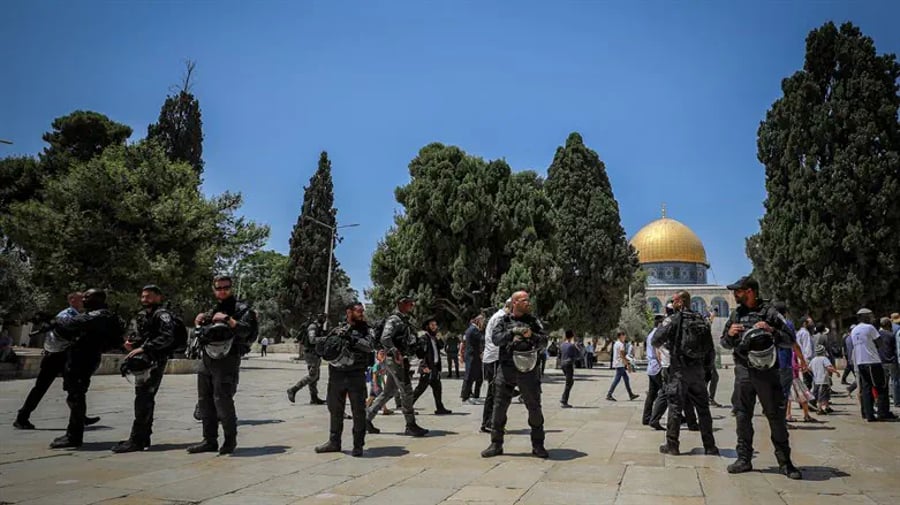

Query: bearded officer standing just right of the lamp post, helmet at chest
(315, 302), (374, 457)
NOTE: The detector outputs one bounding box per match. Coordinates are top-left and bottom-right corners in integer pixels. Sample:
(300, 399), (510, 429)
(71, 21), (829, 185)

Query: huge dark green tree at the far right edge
(751, 22), (900, 319)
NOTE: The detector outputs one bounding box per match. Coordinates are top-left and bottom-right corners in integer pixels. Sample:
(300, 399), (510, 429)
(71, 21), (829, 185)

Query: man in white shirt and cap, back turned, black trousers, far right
(850, 308), (897, 422)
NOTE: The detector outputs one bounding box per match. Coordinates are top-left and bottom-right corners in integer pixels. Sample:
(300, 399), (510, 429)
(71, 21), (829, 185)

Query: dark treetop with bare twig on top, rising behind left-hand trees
(147, 61), (203, 175)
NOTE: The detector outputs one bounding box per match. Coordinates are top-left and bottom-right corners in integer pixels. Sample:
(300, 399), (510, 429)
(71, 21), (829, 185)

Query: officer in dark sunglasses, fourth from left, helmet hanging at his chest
(187, 275), (258, 454)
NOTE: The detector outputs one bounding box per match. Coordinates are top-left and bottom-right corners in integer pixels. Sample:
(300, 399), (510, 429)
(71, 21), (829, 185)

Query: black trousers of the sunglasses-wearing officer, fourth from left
(197, 352), (241, 442)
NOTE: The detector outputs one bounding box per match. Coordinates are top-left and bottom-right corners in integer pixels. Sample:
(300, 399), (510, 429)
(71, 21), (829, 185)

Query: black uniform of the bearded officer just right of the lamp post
(326, 321), (374, 449)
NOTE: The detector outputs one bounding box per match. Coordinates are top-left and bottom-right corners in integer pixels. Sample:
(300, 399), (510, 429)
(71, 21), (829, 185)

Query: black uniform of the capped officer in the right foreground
(720, 300), (795, 465)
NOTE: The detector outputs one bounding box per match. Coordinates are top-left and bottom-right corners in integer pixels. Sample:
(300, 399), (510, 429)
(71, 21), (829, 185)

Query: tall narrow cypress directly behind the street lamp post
(282, 151), (339, 326)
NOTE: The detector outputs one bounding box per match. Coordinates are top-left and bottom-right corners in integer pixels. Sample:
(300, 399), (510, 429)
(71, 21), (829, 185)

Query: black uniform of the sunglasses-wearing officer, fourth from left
(197, 296), (257, 445)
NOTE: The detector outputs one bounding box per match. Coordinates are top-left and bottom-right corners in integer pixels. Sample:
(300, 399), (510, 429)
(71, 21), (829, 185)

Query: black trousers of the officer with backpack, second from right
(666, 366), (716, 449)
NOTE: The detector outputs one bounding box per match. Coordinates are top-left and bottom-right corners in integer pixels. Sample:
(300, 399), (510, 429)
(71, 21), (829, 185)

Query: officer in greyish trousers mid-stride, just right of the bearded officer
(366, 296), (428, 437)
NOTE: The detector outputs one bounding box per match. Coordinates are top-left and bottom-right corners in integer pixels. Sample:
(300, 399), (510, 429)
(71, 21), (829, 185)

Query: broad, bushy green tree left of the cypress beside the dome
(369, 143), (559, 330)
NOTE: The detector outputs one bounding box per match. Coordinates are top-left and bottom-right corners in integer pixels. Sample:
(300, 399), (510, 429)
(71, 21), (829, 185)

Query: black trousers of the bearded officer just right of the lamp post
(326, 366), (366, 449)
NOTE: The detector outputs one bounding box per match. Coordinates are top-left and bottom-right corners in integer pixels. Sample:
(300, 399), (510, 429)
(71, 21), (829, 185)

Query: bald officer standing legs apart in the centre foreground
(481, 291), (549, 458)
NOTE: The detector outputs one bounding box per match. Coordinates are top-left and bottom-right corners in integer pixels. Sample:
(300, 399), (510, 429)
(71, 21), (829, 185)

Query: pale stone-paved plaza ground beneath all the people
(0, 355), (900, 505)
